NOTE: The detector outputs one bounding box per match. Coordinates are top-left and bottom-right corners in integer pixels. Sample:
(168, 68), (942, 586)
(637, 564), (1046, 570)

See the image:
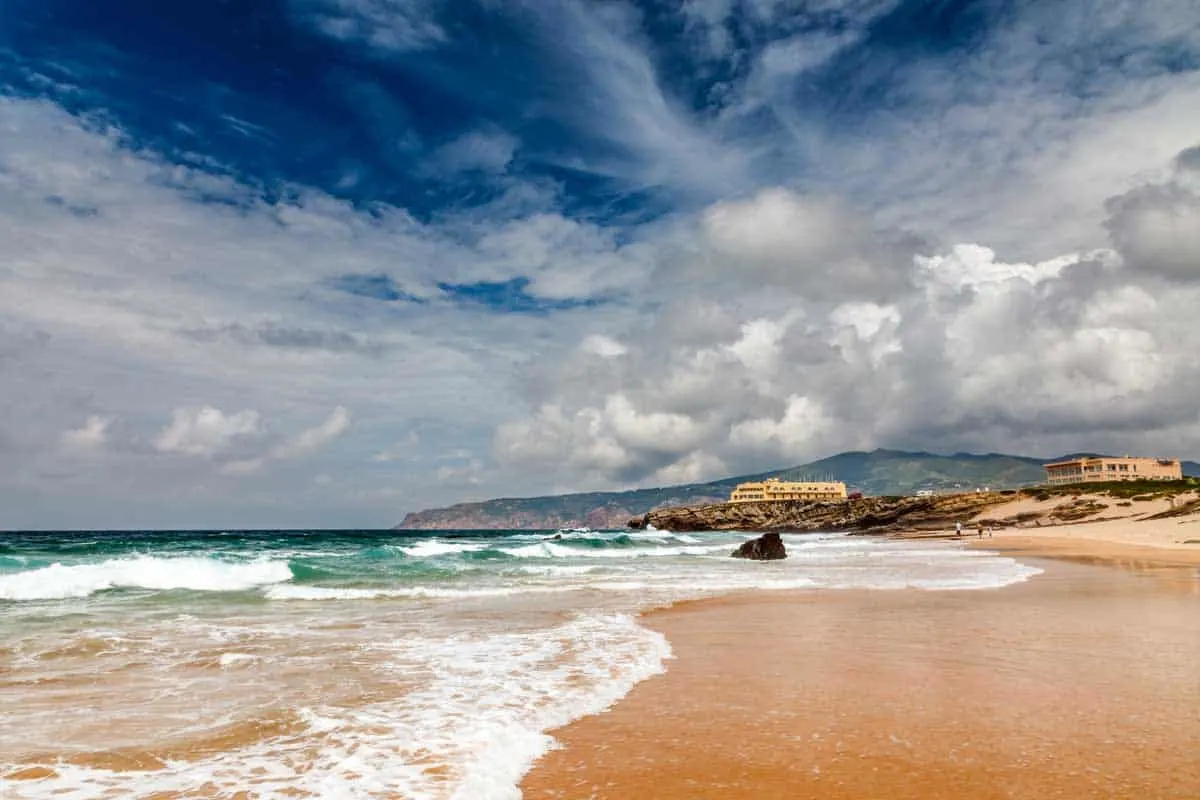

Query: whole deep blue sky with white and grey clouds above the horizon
(0, 0), (1200, 529)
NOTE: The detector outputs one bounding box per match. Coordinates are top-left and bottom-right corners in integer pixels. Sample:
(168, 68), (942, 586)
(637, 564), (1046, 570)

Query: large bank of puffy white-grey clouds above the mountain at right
(494, 155), (1200, 485)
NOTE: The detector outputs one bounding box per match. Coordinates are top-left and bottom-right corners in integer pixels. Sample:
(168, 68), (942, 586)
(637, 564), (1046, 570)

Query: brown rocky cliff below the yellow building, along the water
(629, 492), (1013, 533)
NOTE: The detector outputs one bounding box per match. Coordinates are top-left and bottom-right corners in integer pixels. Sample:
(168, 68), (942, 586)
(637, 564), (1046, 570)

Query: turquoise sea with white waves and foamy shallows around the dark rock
(0, 529), (1038, 800)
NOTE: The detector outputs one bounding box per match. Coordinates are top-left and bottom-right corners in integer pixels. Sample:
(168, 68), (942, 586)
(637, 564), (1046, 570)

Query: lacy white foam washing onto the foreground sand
(0, 614), (671, 800)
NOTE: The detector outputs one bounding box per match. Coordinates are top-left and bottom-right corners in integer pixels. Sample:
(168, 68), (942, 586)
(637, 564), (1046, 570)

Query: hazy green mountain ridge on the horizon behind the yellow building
(397, 450), (1051, 530)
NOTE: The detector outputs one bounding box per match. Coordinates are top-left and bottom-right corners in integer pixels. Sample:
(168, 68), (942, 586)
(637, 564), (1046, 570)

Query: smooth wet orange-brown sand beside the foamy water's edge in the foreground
(522, 556), (1200, 800)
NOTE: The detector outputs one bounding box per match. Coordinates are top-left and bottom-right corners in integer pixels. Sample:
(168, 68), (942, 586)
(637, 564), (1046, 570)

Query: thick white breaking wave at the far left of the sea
(0, 555), (292, 600)
